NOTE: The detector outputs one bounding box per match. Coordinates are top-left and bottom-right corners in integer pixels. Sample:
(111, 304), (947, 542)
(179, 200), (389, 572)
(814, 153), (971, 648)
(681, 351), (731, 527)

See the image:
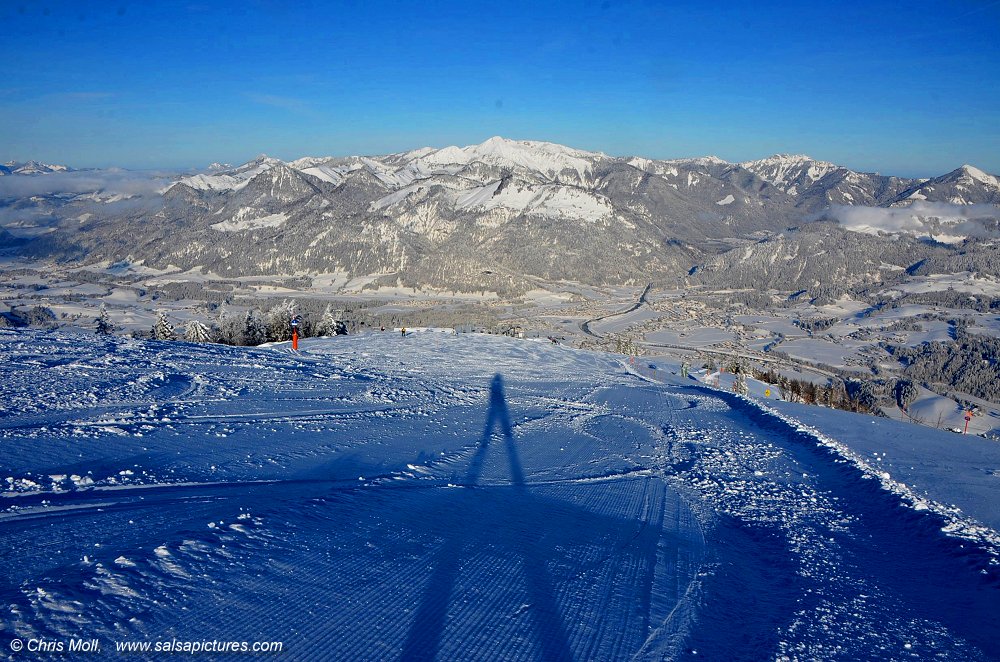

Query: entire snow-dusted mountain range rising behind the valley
(0, 137), (1000, 291)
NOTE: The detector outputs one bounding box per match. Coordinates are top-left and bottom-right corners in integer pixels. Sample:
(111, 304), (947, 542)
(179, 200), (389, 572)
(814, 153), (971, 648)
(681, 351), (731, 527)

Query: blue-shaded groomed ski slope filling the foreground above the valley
(0, 331), (1000, 660)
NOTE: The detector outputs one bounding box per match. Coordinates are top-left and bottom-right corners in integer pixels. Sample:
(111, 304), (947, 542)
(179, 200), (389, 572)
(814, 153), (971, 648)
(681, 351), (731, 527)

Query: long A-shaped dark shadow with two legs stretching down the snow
(400, 374), (573, 660)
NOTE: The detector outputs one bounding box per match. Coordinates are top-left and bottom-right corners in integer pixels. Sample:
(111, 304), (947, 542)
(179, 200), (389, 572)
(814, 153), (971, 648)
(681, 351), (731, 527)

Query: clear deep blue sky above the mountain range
(0, 0), (1000, 176)
